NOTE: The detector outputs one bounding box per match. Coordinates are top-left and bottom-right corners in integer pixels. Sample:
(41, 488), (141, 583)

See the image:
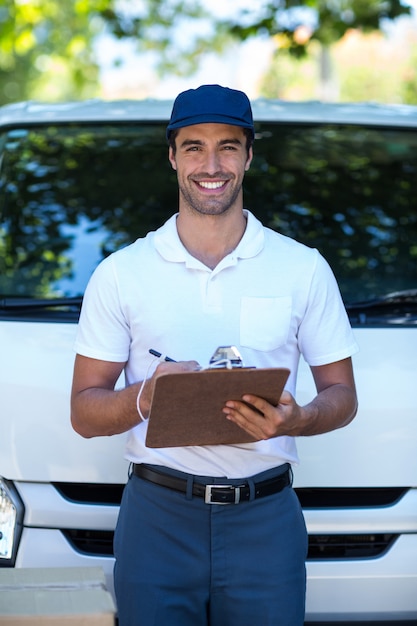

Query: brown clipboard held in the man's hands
(146, 368), (290, 448)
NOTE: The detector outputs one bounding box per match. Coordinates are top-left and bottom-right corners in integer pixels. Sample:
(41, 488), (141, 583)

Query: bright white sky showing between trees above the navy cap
(97, 0), (417, 99)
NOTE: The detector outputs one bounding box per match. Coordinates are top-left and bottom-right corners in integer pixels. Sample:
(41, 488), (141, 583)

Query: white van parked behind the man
(0, 101), (417, 624)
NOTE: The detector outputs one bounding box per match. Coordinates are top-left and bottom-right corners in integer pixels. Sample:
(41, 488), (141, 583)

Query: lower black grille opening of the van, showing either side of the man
(62, 529), (398, 560)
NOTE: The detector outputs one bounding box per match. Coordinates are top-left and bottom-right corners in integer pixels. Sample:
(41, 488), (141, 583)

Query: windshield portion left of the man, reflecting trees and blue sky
(0, 125), (173, 297)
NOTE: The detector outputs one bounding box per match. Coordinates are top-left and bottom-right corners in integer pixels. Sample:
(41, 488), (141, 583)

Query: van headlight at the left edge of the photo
(0, 477), (24, 567)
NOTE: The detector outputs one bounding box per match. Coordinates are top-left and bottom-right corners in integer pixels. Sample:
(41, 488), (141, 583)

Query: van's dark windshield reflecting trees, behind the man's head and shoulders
(0, 123), (417, 320)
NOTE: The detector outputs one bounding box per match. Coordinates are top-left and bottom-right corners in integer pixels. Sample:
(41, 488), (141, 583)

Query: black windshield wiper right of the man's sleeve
(346, 289), (417, 324)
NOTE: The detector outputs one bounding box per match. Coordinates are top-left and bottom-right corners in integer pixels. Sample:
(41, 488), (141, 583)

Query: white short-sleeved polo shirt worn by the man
(75, 211), (357, 478)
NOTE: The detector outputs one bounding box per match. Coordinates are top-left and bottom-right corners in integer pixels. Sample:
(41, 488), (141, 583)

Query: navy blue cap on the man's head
(167, 85), (254, 139)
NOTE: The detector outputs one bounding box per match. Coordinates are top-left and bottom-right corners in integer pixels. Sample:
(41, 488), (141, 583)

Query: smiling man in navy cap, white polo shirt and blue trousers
(72, 85), (357, 626)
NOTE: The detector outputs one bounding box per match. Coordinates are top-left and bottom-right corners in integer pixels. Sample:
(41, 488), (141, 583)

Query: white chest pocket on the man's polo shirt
(240, 296), (291, 352)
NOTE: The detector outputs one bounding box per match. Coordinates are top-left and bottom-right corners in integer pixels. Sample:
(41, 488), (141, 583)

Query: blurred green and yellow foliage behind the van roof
(0, 0), (417, 104)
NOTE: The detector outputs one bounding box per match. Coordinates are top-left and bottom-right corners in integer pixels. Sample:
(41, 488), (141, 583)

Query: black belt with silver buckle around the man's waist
(133, 464), (291, 504)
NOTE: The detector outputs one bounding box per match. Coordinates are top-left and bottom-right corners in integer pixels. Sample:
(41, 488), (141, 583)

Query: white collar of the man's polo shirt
(154, 209), (265, 268)
